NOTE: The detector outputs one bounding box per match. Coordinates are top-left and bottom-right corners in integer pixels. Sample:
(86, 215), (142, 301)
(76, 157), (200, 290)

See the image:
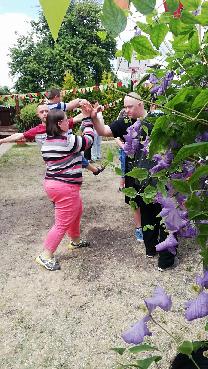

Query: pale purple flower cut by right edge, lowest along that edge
(185, 292), (208, 321)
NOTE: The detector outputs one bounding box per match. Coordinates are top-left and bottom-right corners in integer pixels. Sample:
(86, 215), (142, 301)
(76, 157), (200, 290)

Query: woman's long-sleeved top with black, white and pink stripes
(41, 118), (94, 185)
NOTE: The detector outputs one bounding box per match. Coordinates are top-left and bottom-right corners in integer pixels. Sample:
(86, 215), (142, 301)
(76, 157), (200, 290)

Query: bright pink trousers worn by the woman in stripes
(44, 179), (82, 252)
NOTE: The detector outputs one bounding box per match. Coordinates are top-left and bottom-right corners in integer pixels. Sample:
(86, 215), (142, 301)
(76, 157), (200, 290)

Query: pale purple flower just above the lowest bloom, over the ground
(144, 286), (172, 314)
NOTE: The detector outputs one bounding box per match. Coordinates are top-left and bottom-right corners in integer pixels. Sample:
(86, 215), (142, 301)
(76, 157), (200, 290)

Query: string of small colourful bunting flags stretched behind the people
(0, 81), (122, 102)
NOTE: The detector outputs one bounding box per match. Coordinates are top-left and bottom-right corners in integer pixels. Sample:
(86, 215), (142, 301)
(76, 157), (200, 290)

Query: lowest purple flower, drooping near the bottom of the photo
(121, 315), (152, 345)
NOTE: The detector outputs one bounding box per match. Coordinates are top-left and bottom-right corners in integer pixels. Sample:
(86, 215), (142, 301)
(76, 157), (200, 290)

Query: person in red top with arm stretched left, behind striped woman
(0, 105), (48, 146)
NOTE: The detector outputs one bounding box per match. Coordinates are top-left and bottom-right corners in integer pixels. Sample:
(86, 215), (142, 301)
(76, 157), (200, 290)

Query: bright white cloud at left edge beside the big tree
(0, 13), (31, 87)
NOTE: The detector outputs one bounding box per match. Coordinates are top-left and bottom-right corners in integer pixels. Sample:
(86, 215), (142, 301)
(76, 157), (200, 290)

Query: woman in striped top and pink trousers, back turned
(36, 109), (94, 271)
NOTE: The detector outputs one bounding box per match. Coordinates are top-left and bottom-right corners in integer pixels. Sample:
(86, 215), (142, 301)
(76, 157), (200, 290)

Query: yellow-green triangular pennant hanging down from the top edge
(39, 0), (70, 41)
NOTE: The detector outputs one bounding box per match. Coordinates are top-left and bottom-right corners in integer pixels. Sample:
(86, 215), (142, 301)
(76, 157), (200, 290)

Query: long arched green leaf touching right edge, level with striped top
(173, 142), (208, 165)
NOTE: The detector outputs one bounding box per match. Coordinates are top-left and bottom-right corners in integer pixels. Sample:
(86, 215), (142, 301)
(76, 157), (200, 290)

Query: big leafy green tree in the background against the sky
(9, 0), (116, 92)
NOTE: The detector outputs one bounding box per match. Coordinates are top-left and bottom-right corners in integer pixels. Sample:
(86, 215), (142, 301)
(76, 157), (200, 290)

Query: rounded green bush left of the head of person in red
(16, 104), (39, 132)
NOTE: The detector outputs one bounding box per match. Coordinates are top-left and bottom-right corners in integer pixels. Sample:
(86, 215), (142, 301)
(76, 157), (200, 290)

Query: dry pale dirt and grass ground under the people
(0, 144), (205, 369)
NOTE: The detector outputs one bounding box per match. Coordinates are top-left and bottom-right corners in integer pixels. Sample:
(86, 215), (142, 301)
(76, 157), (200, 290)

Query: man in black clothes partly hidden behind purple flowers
(94, 92), (175, 271)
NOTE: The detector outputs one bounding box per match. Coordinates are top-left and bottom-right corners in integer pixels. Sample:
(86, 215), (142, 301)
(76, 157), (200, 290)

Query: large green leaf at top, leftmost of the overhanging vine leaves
(100, 0), (127, 37)
